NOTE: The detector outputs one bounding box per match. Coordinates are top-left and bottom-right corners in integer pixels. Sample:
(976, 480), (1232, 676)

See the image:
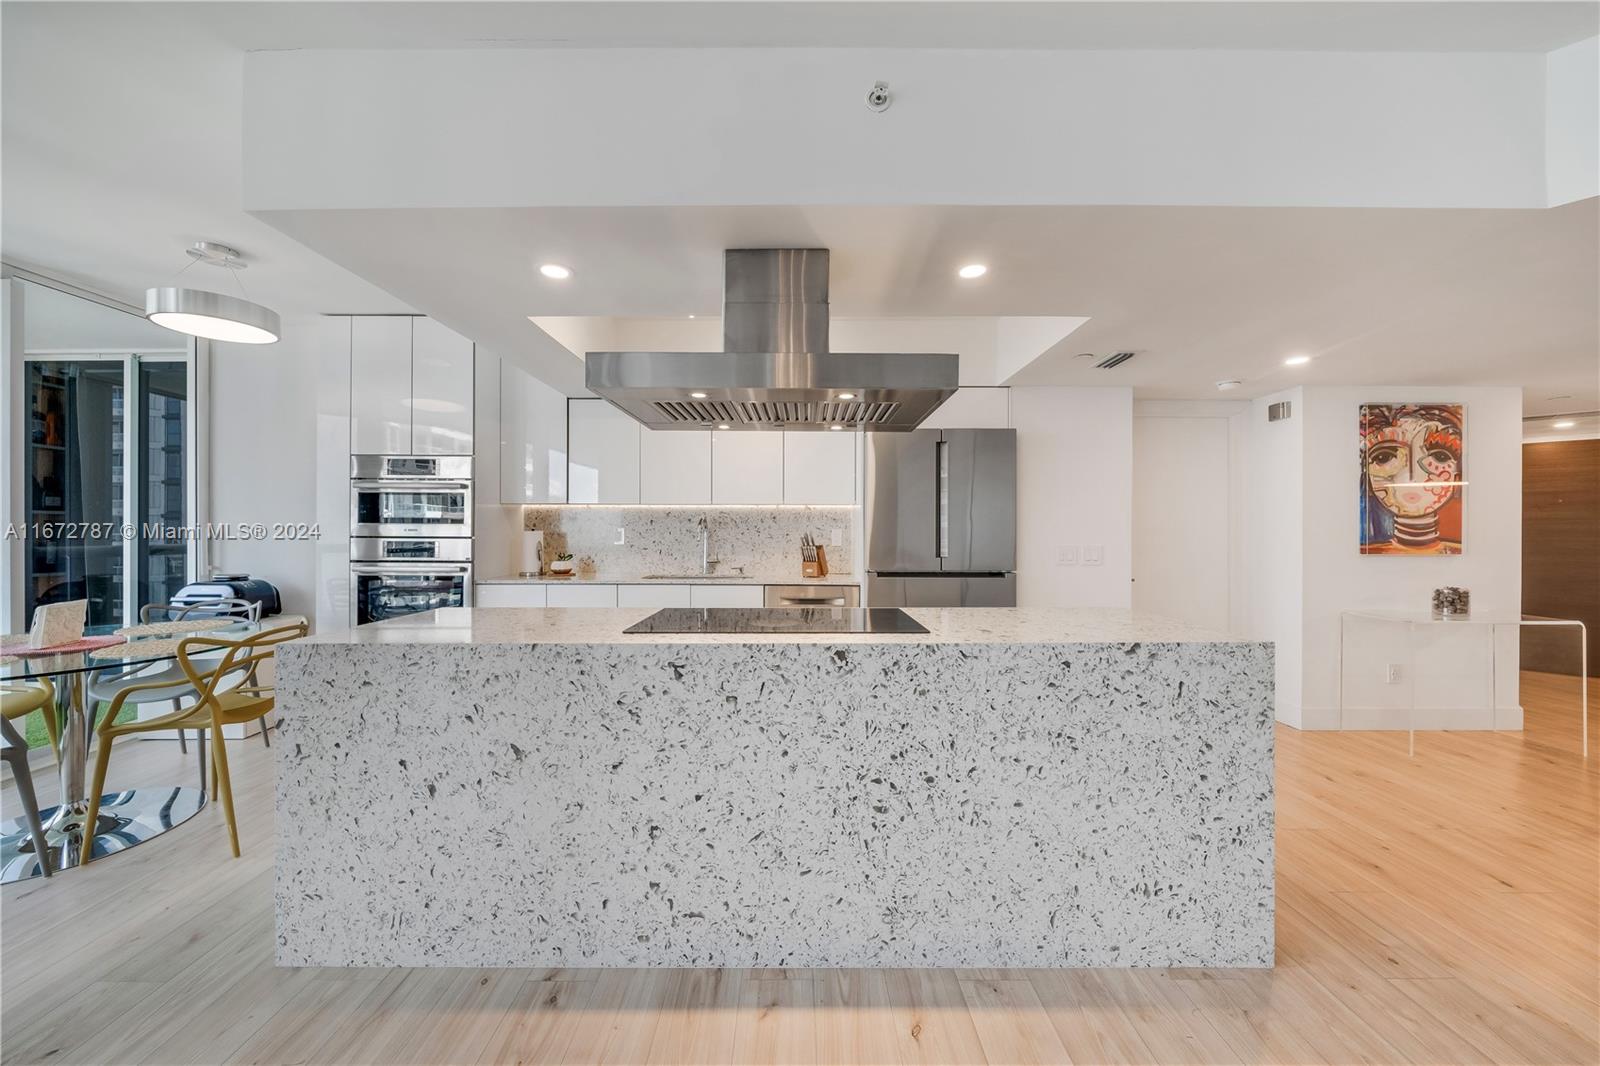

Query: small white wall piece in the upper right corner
(1544, 37), (1600, 206)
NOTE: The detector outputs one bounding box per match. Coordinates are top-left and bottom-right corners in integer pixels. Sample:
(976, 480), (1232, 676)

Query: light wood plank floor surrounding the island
(0, 674), (1600, 1063)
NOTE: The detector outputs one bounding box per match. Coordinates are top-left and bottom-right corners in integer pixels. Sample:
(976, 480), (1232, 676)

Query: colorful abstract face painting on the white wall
(1360, 403), (1466, 555)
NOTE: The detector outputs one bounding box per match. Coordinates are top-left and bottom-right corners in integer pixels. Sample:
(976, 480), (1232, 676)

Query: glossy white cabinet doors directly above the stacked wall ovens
(350, 315), (472, 455)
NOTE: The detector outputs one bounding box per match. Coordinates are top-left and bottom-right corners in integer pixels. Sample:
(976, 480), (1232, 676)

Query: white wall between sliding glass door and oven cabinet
(210, 315), (323, 618)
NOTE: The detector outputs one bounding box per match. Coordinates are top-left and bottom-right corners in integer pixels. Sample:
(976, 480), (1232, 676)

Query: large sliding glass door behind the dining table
(5, 282), (198, 629)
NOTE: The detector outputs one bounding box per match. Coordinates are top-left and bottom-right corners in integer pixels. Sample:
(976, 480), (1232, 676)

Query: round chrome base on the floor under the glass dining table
(0, 787), (206, 885)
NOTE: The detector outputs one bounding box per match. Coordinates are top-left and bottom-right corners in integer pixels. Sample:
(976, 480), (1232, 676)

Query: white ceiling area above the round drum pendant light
(0, 3), (410, 315)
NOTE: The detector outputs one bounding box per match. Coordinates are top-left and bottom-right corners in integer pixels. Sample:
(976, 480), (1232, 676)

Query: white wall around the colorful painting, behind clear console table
(1245, 386), (1522, 728)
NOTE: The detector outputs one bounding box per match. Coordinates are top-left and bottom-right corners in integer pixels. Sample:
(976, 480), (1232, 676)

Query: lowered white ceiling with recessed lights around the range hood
(259, 198), (1600, 415)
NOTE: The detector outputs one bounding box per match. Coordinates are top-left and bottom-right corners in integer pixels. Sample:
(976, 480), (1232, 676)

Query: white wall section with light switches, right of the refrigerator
(1011, 387), (1133, 607)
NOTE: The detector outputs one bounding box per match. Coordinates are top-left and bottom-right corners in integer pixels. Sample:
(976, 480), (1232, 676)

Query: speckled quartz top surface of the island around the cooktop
(301, 607), (1248, 645)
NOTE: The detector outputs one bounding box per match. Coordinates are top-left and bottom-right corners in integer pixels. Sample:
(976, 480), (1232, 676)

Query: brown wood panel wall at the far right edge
(1522, 440), (1600, 675)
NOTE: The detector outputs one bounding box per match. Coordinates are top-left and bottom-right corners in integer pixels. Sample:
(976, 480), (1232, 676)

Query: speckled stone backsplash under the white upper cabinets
(523, 507), (856, 579)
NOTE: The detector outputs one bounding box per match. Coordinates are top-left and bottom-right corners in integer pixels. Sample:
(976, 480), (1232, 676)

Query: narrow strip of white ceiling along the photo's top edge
(50, 0), (1600, 51)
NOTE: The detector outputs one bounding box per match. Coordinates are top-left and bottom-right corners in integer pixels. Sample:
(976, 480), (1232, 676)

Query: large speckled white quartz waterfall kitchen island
(274, 608), (1274, 967)
